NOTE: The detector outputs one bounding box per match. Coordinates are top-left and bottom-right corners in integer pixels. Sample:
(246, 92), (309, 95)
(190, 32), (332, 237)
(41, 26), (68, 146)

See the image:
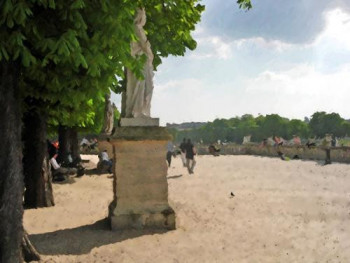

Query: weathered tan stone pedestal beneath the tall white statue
(109, 127), (175, 230)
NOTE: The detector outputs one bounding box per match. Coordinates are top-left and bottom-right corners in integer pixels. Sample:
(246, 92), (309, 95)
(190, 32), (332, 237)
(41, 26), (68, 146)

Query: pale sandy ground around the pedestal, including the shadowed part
(24, 156), (350, 263)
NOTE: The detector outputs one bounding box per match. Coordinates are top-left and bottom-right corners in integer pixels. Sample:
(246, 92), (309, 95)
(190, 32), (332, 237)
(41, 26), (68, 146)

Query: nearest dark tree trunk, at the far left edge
(0, 60), (24, 263)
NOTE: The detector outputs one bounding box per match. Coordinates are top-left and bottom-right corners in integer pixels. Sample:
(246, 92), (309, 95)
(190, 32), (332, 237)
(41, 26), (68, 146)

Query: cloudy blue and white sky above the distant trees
(113, 0), (350, 125)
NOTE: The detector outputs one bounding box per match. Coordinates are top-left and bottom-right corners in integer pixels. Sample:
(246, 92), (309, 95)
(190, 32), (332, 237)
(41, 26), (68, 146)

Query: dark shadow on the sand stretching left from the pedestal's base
(29, 218), (169, 255)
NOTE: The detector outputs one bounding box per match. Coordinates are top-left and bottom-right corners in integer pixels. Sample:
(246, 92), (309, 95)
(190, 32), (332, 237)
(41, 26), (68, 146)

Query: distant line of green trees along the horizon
(169, 112), (350, 143)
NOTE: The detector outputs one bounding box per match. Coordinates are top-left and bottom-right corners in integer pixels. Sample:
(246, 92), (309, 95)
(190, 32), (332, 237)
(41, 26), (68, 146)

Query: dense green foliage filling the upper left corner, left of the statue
(0, 0), (139, 132)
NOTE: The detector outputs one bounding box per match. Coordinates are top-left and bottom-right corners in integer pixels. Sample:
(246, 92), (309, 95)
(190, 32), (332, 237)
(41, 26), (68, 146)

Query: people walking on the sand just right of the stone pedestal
(166, 138), (197, 174)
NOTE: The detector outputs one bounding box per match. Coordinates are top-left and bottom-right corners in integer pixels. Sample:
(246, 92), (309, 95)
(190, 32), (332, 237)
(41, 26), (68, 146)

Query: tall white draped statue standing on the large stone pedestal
(125, 9), (154, 118)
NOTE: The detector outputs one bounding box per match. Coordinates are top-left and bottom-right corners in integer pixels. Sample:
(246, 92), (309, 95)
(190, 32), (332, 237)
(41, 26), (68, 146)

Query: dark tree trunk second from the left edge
(23, 108), (54, 208)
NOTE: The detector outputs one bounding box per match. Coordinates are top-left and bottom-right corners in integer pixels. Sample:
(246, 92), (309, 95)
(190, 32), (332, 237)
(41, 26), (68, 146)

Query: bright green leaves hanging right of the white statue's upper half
(140, 0), (204, 69)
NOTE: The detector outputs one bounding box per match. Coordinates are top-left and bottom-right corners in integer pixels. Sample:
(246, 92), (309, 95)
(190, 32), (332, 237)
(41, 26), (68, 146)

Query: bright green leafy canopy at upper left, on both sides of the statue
(0, 0), (251, 136)
